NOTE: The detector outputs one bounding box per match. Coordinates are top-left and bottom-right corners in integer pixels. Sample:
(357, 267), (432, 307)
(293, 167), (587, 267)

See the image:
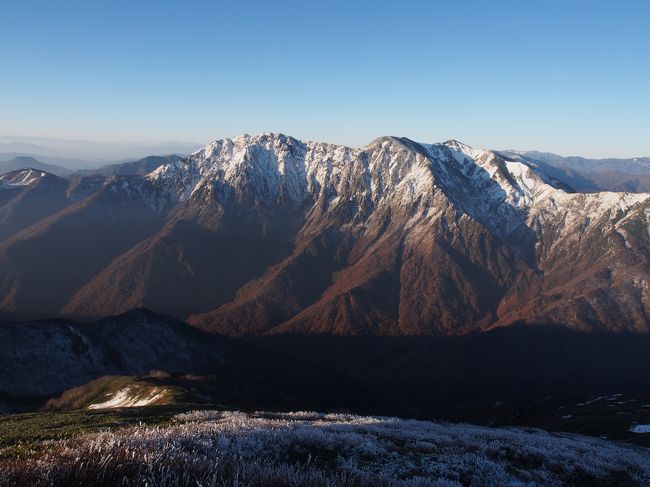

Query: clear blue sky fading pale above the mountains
(0, 0), (650, 156)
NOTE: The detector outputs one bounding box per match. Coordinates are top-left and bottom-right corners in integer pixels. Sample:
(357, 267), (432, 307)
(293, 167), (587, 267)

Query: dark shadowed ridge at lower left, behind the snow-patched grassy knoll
(0, 310), (384, 418)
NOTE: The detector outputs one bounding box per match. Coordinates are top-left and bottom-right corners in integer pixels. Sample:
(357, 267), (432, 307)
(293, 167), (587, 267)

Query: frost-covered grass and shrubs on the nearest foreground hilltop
(0, 411), (650, 486)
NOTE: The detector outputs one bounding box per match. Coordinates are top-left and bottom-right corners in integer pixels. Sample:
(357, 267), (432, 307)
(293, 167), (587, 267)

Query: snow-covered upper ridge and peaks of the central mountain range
(147, 133), (650, 246)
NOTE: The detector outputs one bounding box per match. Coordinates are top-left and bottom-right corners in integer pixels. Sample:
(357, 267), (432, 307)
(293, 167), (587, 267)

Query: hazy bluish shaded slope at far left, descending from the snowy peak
(0, 177), (164, 319)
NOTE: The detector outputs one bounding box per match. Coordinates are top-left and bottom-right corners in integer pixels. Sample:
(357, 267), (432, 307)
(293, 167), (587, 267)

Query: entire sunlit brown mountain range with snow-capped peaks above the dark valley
(0, 133), (650, 335)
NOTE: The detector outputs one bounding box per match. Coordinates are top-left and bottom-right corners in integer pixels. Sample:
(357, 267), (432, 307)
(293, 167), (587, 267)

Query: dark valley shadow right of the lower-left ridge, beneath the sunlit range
(250, 325), (650, 417)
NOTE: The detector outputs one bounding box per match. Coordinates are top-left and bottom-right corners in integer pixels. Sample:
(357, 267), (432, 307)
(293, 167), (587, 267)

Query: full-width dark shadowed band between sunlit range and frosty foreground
(0, 310), (650, 441)
